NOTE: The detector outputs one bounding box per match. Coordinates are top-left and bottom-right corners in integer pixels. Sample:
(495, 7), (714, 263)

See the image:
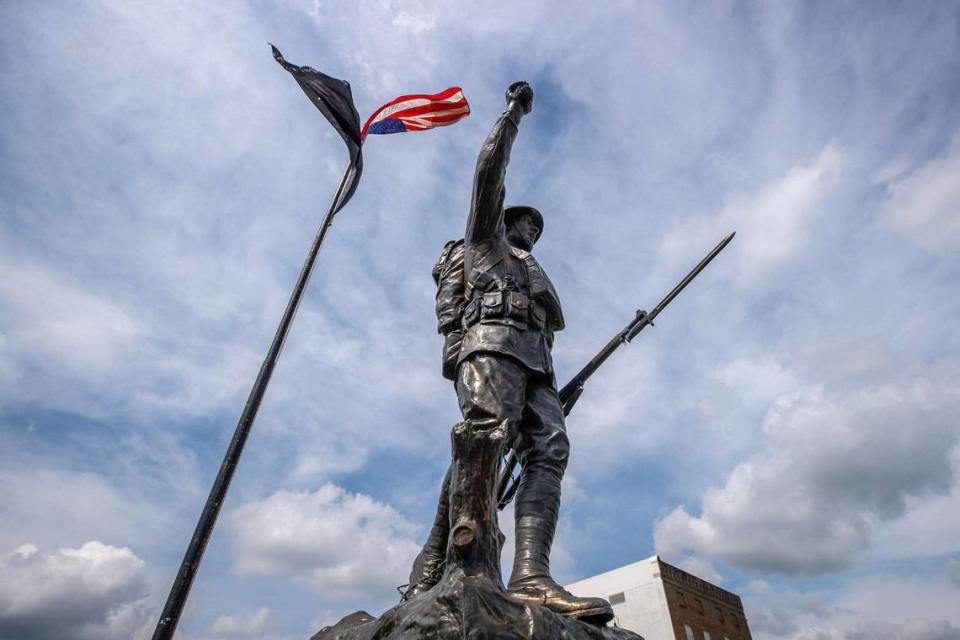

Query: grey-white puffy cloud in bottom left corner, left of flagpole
(0, 541), (152, 640)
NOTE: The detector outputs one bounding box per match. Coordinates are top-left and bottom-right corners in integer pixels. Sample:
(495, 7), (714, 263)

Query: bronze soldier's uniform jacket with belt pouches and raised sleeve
(434, 112), (564, 377)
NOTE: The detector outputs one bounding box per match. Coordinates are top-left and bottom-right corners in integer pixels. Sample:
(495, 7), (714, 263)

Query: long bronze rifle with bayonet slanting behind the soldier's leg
(497, 231), (737, 510)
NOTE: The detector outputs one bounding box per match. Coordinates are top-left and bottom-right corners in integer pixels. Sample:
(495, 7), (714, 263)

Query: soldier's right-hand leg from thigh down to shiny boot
(508, 375), (613, 623)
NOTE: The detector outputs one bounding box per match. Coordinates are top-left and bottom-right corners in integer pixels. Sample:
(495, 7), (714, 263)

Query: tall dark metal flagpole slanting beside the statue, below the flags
(153, 163), (353, 640)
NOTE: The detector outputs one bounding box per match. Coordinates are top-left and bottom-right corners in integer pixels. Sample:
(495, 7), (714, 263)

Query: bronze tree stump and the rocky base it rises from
(311, 421), (643, 640)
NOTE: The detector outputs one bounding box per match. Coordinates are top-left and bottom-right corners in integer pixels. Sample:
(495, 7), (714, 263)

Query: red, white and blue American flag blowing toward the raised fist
(360, 87), (470, 140)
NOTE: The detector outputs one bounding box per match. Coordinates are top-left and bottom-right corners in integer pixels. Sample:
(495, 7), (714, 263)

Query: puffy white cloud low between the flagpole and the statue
(229, 484), (420, 601)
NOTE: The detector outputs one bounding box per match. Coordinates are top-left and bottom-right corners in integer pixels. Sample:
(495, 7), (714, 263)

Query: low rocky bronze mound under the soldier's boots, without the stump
(310, 570), (643, 640)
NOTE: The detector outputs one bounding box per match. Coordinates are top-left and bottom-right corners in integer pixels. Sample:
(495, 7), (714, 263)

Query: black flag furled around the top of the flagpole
(270, 44), (363, 213)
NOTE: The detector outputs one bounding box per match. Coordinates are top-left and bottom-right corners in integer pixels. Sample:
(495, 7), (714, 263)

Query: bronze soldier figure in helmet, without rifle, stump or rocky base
(405, 82), (613, 623)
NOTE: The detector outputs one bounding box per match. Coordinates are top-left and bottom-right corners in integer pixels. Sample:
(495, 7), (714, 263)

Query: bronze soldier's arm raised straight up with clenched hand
(464, 82), (533, 245)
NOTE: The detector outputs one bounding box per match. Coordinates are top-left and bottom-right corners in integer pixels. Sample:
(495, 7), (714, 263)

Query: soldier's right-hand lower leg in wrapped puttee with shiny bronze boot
(507, 465), (613, 625)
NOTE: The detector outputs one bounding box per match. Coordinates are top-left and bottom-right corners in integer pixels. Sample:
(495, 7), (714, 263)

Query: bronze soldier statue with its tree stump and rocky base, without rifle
(314, 82), (642, 640)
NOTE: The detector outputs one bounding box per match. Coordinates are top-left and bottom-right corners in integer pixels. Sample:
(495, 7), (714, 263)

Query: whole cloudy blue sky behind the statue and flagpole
(0, 0), (960, 640)
